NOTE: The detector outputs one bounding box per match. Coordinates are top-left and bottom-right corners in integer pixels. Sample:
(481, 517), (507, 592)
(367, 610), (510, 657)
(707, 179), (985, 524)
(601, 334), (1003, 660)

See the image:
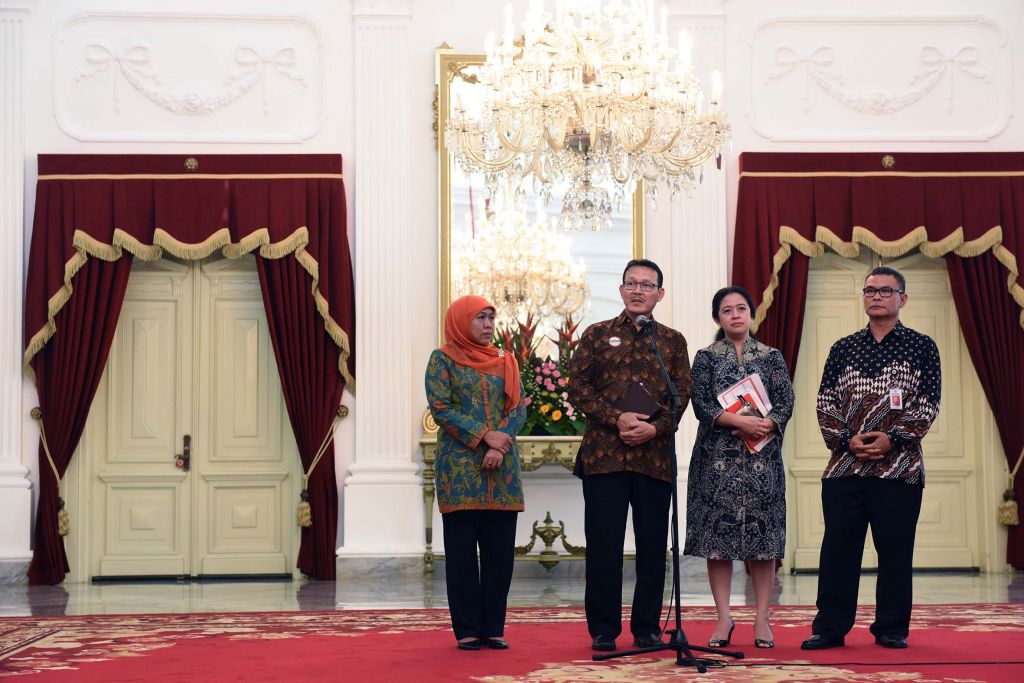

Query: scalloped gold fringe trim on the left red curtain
(24, 227), (355, 394)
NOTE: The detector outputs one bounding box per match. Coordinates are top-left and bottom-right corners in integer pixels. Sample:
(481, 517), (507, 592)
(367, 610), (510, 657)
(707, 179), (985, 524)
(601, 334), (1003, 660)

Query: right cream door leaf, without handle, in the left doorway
(196, 258), (300, 574)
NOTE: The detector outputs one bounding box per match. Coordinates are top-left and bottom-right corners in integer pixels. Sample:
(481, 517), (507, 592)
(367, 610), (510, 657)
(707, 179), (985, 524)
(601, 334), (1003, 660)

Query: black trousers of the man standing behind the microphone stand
(583, 472), (672, 638)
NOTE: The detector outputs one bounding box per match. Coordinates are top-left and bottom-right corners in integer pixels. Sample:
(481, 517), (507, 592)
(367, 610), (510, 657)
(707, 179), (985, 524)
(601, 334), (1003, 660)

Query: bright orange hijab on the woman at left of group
(440, 295), (519, 415)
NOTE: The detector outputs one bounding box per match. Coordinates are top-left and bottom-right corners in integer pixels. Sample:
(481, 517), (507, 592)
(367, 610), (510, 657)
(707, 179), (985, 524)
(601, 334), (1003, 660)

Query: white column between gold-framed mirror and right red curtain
(666, 5), (731, 507)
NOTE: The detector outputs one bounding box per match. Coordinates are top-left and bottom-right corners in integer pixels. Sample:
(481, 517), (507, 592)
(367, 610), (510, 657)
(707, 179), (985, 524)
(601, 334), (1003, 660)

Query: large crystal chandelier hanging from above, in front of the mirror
(444, 0), (729, 229)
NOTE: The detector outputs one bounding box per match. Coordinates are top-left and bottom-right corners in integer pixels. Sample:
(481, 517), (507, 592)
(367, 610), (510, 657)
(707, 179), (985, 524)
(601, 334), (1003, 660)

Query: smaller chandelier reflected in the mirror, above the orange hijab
(452, 202), (590, 327)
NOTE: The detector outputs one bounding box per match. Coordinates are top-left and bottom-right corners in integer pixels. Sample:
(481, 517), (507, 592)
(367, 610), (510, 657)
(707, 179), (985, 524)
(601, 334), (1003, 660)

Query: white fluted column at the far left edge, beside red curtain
(0, 0), (32, 583)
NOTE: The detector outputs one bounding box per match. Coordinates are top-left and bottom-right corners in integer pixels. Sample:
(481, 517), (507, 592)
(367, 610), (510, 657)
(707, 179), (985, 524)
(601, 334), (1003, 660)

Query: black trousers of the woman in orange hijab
(441, 510), (519, 639)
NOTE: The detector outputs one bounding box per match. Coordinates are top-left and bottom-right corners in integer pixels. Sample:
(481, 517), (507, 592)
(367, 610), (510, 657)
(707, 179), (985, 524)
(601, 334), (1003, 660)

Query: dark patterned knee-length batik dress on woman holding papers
(683, 339), (794, 560)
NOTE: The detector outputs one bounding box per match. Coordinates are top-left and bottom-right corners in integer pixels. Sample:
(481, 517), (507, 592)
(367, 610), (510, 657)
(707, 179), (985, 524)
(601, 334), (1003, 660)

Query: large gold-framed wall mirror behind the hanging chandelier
(435, 46), (644, 352)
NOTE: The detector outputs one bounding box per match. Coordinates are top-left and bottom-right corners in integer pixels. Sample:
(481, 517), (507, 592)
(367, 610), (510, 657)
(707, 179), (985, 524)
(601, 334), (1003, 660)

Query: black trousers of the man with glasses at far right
(811, 476), (924, 638)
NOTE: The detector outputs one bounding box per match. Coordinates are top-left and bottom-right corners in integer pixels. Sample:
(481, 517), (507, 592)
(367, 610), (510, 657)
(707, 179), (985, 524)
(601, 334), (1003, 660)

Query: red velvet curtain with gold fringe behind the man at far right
(733, 153), (1024, 568)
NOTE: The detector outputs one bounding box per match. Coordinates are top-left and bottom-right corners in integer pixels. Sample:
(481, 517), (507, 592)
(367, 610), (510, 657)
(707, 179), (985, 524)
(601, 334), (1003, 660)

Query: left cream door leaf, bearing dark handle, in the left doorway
(90, 261), (193, 577)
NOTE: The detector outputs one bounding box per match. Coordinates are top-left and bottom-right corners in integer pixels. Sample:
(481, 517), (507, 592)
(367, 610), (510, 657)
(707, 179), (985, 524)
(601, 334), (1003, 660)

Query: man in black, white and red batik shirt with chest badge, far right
(803, 267), (942, 650)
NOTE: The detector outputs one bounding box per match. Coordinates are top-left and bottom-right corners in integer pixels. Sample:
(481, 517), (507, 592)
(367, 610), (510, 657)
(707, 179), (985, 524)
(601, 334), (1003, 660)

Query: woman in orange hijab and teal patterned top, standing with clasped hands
(426, 296), (526, 650)
